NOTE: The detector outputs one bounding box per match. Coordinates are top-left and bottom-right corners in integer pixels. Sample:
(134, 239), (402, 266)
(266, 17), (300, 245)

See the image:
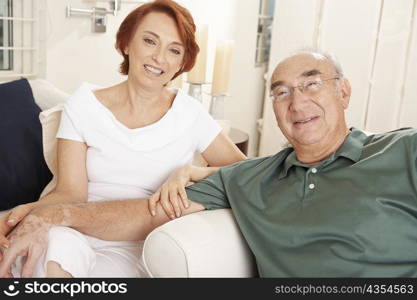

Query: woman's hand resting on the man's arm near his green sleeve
(149, 165), (195, 219)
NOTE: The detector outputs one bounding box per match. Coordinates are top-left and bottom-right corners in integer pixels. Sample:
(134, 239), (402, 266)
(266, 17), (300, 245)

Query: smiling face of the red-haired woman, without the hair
(124, 12), (185, 87)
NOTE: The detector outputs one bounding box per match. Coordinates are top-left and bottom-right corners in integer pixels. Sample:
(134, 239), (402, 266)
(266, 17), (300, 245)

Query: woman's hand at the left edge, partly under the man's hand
(0, 203), (34, 260)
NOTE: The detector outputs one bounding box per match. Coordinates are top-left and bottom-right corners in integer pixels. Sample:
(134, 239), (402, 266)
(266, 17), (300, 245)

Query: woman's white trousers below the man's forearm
(13, 226), (147, 277)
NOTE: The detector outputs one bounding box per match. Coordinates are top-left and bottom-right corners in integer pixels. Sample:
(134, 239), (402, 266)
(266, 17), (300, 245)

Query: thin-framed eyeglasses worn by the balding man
(270, 77), (340, 102)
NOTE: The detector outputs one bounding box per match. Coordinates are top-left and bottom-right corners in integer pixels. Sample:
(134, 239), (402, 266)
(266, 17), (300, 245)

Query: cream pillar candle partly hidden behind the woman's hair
(188, 24), (208, 84)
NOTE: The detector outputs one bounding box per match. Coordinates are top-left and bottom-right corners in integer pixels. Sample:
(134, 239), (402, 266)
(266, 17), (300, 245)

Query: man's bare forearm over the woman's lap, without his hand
(46, 199), (204, 241)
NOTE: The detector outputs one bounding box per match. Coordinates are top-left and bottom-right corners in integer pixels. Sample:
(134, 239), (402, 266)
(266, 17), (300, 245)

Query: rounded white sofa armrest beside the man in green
(143, 209), (257, 277)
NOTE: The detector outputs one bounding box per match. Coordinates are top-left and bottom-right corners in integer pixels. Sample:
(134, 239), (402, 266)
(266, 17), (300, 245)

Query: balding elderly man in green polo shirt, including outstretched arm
(0, 52), (417, 277)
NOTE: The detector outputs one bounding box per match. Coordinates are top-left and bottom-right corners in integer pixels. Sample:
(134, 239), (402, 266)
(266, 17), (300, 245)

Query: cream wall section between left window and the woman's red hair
(45, 0), (136, 93)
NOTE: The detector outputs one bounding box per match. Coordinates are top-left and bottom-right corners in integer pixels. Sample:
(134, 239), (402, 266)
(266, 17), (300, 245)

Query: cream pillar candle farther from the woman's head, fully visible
(211, 40), (234, 95)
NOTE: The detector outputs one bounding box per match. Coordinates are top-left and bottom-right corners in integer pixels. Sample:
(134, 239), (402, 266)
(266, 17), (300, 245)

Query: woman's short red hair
(116, 0), (200, 79)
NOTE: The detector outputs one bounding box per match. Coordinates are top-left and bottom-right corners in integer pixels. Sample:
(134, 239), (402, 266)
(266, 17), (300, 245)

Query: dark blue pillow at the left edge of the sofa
(0, 79), (52, 210)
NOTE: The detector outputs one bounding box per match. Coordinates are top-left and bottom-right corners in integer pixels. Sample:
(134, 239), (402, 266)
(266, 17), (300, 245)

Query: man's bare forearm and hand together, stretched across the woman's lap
(0, 199), (204, 277)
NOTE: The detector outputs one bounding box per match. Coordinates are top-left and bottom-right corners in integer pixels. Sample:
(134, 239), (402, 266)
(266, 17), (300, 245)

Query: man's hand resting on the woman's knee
(0, 209), (52, 278)
